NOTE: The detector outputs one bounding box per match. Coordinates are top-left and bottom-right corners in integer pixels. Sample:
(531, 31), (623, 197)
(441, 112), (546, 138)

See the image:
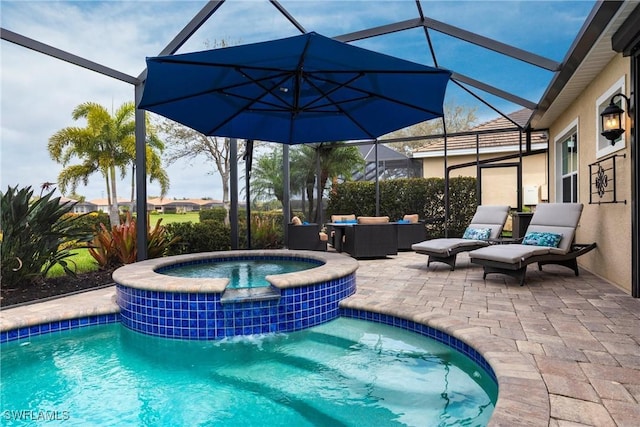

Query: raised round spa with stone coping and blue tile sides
(113, 250), (358, 340)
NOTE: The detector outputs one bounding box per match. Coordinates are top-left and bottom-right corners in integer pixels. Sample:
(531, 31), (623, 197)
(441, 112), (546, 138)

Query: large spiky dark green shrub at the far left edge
(0, 186), (91, 287)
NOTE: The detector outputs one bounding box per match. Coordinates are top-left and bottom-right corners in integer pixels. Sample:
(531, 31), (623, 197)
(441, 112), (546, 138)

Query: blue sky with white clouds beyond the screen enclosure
(0, 0), (594, 200)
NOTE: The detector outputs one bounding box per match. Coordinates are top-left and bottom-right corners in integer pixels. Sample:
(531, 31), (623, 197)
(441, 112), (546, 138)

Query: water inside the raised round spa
(161, 259), (319, 289)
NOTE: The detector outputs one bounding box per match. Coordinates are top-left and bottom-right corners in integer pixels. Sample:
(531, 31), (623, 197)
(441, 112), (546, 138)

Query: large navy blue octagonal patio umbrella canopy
(138, 33), (451, 144)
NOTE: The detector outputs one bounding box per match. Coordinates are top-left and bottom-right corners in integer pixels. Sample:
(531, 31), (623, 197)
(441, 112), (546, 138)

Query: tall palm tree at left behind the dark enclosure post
(48, 102), (169, 225)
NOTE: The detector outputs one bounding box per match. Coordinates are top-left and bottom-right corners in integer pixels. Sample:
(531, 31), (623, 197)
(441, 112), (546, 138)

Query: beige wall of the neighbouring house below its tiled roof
(422, 153), (547, 208)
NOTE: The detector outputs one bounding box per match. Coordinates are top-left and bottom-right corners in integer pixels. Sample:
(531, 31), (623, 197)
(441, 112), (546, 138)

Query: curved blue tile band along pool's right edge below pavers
(340, 308), (498, 384)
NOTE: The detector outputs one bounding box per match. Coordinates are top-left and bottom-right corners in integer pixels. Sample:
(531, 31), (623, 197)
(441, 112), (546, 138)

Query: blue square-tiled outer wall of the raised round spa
(117, 274), (356, 340)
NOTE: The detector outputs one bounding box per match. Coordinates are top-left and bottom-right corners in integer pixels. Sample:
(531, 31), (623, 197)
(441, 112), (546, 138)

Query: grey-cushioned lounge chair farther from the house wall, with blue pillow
(411, 205), (509, 271)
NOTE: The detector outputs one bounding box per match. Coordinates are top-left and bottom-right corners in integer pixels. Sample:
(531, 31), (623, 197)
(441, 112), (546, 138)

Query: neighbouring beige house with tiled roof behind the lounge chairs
(413, 109), (548, 207)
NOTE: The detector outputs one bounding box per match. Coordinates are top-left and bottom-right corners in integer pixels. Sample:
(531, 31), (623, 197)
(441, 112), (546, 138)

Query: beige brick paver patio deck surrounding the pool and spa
(0, 252), (640, 427)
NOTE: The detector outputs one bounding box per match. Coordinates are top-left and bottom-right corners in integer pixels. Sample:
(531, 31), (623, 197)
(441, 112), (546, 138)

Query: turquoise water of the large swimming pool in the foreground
(0, 318), (497, 426)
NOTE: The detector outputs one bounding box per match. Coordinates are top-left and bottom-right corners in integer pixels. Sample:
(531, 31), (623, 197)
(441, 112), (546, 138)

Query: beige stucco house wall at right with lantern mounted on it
(549, 54), (631, 293)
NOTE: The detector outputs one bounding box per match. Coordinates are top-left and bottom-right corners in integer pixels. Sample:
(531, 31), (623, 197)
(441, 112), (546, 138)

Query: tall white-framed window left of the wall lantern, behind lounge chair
(555, 121), (578, 203)
